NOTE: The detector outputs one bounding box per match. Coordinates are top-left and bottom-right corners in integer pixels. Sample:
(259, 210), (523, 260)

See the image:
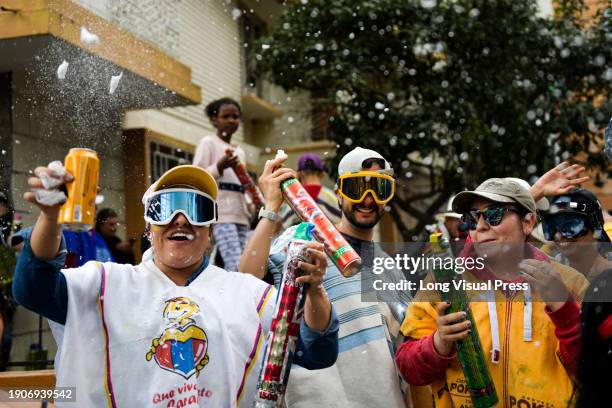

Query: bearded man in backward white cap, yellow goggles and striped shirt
(240, 147), (410, 408)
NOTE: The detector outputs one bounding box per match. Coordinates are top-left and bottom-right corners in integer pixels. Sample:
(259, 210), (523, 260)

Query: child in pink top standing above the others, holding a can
(193, 98), (251, 271)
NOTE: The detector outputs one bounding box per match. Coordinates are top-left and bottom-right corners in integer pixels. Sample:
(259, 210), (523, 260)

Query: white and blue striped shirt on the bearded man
(268, 227), (410, 408)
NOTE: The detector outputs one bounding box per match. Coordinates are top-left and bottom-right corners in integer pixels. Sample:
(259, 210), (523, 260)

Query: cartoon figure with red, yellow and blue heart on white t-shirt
(146, 297), (209, 378)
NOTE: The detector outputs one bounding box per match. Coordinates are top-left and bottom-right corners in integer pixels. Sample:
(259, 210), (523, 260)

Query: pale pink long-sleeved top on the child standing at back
(193, 135), (249, 225)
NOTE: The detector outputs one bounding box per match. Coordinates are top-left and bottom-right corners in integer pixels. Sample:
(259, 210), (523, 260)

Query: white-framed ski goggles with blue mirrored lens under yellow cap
(144, 188), (217, 227)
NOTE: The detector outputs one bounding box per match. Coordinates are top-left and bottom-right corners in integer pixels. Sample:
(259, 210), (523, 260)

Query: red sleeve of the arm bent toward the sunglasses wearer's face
(546, 301), (580, 374)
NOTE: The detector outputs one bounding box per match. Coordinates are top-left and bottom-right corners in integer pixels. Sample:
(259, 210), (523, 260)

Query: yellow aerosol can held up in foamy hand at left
(58, 148), (100, 231)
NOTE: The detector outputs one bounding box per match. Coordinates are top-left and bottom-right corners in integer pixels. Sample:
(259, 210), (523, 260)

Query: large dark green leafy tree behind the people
(252, 0), (612, 240)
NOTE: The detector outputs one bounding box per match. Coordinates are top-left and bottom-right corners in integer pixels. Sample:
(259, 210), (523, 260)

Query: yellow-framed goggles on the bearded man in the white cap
(338, 171), (395, 205)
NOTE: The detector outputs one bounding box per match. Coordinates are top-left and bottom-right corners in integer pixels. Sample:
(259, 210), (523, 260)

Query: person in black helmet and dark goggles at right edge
(542, 188), (612, 279)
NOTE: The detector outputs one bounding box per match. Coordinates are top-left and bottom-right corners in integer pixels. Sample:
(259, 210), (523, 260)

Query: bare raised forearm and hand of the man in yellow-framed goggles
(238, 158), (296, 279)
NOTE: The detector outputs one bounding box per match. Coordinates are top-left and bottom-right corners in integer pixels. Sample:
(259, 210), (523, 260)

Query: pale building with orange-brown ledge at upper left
(0, 0), (333, 366)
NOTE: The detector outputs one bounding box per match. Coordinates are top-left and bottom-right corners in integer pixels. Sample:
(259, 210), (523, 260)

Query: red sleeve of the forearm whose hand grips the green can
(395, 334), (457, 385)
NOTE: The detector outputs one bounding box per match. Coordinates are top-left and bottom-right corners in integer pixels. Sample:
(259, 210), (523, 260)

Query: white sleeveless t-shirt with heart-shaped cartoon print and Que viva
(51, 260), (276, 408)
